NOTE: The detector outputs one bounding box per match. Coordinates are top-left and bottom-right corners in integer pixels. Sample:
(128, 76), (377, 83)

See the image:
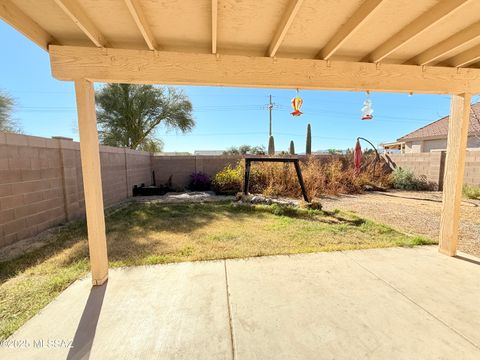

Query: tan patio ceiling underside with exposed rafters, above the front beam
(1, 0), (480, 67)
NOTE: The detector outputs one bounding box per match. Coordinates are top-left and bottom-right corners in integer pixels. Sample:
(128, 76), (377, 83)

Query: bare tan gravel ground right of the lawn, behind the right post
(322, 191), (480, 257)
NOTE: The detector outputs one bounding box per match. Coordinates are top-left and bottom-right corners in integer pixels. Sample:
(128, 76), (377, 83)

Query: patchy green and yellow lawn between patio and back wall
(0, 203), (433, 339)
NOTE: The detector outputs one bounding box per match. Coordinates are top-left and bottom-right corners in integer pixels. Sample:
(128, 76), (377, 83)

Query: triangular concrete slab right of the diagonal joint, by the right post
(345, 247), (480, 345)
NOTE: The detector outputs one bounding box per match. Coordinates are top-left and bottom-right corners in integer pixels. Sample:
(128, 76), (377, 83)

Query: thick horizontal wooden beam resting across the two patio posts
(49, 45), (480, 94)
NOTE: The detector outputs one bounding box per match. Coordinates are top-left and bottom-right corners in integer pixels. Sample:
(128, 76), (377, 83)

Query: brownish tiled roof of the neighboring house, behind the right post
(397, 102), (480, 141)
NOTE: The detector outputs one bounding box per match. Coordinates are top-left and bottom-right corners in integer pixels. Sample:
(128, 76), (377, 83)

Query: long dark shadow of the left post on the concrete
(67, 280), (108, 360)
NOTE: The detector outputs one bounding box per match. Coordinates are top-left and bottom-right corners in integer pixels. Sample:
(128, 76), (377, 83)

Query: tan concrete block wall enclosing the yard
(0, 133), (480, 248)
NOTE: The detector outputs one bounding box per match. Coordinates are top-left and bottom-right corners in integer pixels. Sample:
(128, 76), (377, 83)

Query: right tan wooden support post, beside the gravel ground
(439, 94), (471, 256)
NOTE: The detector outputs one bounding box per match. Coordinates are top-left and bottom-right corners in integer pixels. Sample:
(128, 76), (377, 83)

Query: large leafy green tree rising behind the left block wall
(96, 84), (195, 152)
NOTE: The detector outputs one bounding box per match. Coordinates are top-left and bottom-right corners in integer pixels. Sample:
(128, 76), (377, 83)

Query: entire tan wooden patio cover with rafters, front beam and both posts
(0, 0), (480, 285)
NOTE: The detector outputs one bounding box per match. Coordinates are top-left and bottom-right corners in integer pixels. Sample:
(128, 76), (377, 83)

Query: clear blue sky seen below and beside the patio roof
(0, 20), (477, 152)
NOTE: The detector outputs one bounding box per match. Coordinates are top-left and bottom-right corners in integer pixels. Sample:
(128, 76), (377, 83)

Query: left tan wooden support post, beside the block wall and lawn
(75, 79), (108, 285)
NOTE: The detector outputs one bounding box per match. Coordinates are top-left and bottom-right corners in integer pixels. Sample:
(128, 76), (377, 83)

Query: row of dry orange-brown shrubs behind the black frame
(213, 155), (390, 199)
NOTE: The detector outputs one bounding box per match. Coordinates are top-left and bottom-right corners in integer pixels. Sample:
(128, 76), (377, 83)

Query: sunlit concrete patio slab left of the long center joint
(0, 261), (232, 360)
